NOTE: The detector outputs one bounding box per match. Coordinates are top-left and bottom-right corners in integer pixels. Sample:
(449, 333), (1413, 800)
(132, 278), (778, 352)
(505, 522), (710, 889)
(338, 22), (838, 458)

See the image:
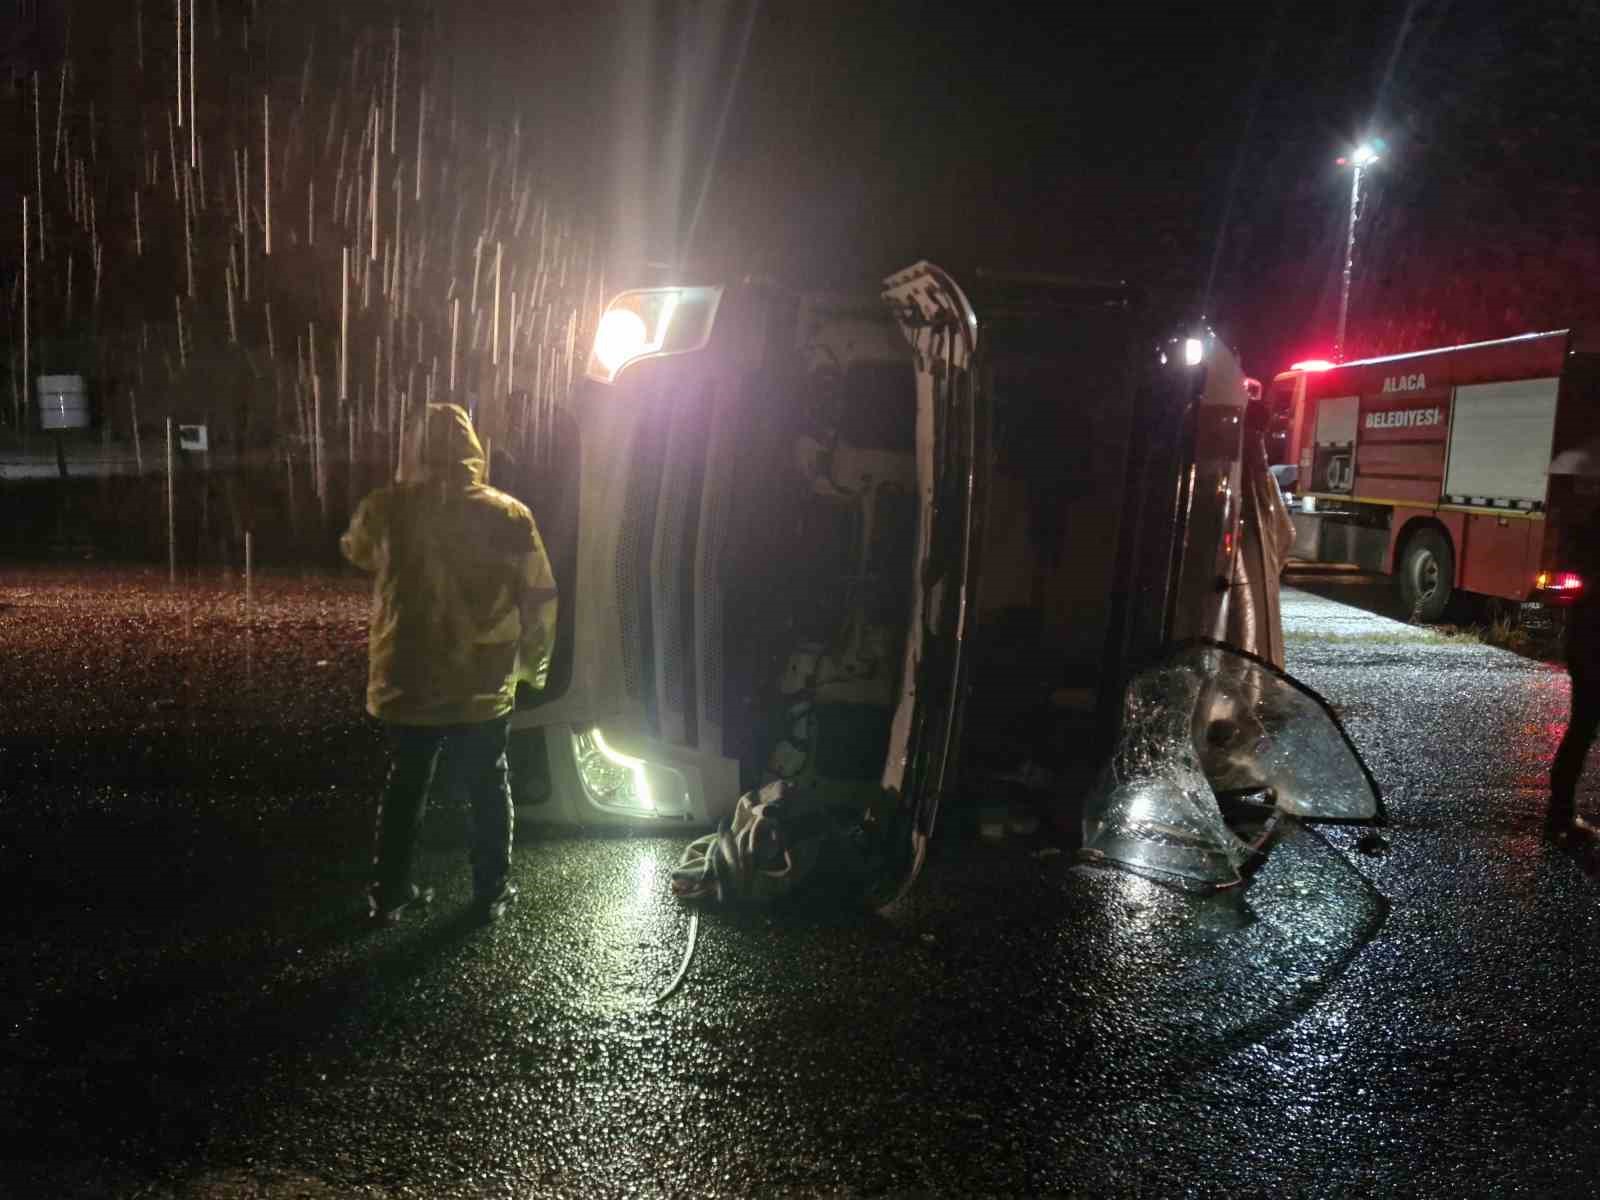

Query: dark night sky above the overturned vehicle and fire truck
(5, 0), (1600, 385)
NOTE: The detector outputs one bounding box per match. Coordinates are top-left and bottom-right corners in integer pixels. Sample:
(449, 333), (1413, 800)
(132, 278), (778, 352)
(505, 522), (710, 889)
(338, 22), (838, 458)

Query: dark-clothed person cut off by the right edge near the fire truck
(1544, 509), (1600, 843)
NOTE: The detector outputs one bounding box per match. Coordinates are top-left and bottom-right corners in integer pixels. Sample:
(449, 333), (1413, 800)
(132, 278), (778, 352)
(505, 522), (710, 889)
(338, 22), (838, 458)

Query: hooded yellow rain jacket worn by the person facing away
(339, 405), (555, 725)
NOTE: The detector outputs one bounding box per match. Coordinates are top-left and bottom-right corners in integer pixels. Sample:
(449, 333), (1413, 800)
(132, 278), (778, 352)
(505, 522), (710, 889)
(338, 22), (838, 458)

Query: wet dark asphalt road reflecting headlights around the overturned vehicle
(0, 574), (1600, 1197)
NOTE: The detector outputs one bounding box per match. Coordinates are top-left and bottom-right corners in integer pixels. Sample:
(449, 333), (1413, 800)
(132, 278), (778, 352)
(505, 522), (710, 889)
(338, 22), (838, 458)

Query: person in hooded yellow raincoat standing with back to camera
(339, 405), (557, 923)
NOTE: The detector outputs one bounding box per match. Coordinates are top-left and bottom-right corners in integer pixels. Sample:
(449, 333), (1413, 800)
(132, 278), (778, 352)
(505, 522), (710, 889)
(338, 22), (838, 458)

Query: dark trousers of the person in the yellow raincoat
(373, 717), (514, 904)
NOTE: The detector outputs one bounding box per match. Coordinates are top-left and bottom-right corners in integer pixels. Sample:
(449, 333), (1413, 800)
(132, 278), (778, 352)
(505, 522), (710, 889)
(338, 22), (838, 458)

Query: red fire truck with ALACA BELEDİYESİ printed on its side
(1270, 330), (1600, 621)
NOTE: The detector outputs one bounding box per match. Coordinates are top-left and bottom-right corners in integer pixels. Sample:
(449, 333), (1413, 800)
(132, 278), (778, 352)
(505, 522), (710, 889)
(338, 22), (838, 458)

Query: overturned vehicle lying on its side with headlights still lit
(496, 262), (1376, 896)
